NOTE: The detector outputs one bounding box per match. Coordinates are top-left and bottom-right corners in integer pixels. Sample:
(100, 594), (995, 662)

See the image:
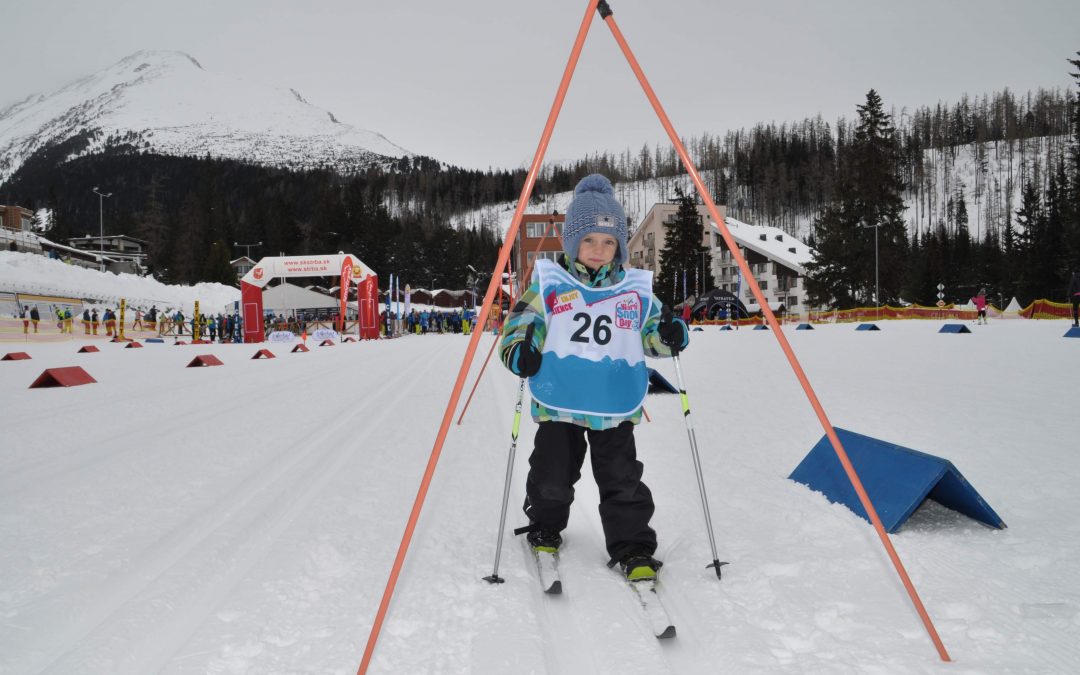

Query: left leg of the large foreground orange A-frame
(356, 0), (599, 675)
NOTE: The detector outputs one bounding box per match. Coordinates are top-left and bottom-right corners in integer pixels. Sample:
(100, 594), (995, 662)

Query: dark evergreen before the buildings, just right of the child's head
(653, 187), (712, 305)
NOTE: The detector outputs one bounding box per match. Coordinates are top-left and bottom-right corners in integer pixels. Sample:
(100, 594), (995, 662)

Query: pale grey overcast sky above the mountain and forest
(6, 0), (1080, 168)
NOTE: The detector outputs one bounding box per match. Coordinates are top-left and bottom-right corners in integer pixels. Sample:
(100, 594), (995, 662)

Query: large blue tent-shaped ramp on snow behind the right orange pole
(788, 428), (1005, 532)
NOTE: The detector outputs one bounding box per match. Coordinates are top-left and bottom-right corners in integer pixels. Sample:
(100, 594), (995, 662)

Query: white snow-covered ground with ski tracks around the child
(0, 313), (1080, 675)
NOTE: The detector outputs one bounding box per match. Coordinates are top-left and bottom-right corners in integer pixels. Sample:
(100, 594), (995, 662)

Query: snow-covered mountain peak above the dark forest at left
(0, 51), (410, 183)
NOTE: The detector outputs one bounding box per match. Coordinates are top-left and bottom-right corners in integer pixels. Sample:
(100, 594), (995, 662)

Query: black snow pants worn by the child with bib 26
(525, 422), (657, 561)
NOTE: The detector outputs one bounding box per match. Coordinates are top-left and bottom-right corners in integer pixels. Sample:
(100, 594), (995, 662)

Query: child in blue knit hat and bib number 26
(500, 174), (689, 580)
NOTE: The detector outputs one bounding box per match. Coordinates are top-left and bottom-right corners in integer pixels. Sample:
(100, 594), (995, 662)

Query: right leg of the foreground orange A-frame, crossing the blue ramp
(600, 1), (951, 661)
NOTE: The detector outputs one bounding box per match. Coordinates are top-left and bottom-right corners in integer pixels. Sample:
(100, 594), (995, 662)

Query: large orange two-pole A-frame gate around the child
(356, 0), (950, 675)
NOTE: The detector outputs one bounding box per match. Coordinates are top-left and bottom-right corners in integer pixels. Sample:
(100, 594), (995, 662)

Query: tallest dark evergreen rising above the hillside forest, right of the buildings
(807, 90), (907, 308)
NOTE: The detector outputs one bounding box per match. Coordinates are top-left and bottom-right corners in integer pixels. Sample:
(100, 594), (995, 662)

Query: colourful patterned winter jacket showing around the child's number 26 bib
(499, 255), (671, 430)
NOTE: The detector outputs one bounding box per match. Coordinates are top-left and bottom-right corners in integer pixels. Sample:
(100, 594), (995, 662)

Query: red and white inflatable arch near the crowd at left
(240, 253), (379, 342)
